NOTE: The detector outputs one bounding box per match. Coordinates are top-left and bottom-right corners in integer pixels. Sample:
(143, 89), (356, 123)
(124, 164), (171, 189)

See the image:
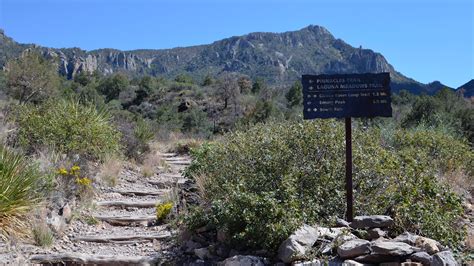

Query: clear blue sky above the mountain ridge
(0, 0), (474, 87)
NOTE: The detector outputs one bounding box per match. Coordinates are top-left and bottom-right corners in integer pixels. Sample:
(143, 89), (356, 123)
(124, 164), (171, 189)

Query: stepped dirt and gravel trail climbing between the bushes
(0, 153), (190, 265)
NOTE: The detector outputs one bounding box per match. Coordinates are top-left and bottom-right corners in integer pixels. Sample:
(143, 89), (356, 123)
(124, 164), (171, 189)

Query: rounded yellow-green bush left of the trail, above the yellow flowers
(16, 100), (120, 159)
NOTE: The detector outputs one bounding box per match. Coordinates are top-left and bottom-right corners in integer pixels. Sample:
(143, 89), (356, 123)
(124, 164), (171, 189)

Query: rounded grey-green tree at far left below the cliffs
(6, 51), (59, 104)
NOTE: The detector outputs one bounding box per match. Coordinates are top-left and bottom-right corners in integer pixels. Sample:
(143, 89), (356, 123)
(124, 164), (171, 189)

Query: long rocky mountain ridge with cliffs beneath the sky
(0, 25), (452, 94)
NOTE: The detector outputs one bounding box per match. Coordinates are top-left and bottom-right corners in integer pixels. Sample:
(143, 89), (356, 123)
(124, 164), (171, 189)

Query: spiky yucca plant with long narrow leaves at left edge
(0, 146), (41, 239)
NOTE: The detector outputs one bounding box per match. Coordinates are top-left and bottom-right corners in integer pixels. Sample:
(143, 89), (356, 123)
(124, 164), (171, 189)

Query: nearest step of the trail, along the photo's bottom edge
(29, 253), (161, 266)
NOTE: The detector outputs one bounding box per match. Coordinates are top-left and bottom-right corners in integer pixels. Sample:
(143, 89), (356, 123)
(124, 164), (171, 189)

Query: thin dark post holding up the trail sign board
(345, 117), (354, 222)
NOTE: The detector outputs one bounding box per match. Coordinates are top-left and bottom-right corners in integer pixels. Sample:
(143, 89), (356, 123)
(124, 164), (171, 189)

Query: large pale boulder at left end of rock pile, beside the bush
(278, 224), (319, 263)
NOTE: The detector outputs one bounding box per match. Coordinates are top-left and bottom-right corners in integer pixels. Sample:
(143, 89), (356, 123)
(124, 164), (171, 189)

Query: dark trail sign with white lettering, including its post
(301, 73), (392, 222)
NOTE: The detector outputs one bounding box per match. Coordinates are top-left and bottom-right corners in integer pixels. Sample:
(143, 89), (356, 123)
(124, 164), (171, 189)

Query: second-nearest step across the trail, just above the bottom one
(73, 232), (171, 244)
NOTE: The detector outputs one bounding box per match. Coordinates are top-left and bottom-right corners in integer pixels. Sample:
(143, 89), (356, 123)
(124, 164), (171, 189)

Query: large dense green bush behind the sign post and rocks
(187, 120), (466, 254)
